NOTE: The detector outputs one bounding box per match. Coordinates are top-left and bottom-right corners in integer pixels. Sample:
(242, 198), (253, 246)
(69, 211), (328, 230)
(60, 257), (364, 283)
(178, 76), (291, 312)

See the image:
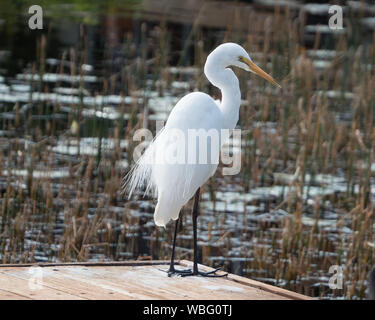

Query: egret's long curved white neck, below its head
(204, 59), (241, 130)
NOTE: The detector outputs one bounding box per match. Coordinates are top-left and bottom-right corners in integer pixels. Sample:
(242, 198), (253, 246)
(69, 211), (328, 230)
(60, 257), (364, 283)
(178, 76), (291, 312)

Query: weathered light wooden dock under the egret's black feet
(0, 260), (310, 300)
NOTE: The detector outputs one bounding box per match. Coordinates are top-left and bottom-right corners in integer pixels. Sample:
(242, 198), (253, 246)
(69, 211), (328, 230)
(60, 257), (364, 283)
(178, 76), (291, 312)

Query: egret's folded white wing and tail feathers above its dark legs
(152, 92), (222, 226)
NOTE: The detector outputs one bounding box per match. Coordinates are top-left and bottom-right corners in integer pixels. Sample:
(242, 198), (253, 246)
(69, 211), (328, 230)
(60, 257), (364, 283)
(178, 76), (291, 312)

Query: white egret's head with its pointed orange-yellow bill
(207, 42), (281, 88)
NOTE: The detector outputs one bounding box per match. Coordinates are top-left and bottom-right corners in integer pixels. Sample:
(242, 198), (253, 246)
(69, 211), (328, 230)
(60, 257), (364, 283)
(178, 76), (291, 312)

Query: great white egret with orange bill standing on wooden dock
(125, 43), (280, 276)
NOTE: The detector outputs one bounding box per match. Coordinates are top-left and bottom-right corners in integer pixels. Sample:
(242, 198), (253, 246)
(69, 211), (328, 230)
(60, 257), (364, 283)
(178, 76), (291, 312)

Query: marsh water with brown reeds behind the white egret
(0, 1), (375, 299)
